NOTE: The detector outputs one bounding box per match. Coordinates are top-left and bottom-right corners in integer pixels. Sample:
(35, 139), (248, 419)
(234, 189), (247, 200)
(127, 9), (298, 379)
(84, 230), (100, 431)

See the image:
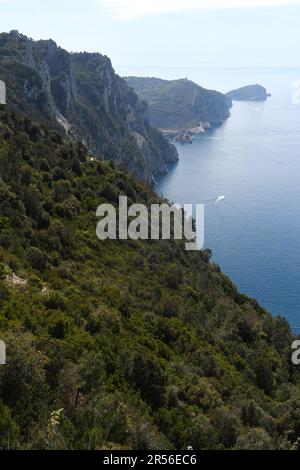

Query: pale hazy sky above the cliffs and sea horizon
(0, 0), (300, 71)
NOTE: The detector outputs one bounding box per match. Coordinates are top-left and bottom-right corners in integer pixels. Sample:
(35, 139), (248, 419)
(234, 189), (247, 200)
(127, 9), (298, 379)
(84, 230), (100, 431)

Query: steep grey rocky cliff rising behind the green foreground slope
(0, 31), (178, 181)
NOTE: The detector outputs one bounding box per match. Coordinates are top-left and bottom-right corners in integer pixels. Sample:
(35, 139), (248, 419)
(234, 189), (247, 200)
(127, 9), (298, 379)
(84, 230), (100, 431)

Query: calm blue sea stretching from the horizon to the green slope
(127, 68), (300, 333)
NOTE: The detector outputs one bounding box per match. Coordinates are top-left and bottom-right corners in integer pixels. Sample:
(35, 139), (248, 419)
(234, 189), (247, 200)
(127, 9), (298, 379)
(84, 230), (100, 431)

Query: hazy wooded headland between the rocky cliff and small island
(126, 77), (230, 140)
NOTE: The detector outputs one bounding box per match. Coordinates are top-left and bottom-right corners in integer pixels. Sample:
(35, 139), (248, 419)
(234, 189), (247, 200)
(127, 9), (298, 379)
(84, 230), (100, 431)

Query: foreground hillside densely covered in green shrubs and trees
(0, 106), (300, 450)
